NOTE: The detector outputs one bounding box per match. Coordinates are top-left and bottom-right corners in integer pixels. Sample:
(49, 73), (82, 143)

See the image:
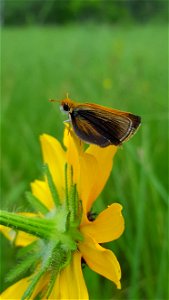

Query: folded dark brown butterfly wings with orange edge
(71, 104), (141, 147)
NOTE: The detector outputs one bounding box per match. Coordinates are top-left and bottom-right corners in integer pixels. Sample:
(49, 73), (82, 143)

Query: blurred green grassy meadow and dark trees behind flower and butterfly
(1, 0), (169, 300)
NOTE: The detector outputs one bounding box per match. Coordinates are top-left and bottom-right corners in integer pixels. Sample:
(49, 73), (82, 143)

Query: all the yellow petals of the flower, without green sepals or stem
(1, 127), (124, 299)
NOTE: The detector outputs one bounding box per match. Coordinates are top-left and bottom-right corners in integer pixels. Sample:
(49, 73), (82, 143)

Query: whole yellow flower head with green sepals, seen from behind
(1, 126), (124, 299)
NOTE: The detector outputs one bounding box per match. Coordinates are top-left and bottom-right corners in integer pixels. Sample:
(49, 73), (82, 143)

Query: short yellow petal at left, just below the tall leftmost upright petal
(31, 180), (54, 210)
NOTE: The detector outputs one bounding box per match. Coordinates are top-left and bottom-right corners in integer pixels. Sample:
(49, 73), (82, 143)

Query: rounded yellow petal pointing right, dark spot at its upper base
(81, 203), (124, 243)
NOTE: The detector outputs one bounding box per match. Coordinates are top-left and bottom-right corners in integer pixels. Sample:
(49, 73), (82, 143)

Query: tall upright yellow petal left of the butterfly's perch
(40, 134), (66, 199)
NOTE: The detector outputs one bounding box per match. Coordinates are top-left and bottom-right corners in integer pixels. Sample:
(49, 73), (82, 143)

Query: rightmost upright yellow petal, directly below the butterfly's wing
(86, 145), (117, 207)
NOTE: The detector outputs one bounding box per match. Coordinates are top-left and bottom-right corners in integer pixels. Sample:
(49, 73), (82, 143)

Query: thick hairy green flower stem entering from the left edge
(0, 211), (54, 239)
